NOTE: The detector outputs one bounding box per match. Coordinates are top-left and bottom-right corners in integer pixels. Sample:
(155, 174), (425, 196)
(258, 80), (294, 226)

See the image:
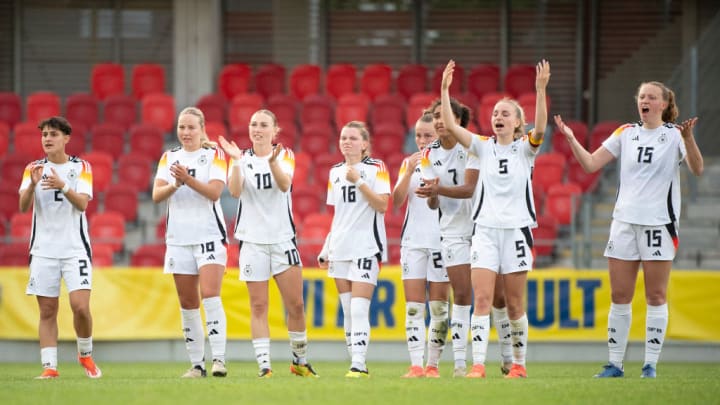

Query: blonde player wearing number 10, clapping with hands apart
(220, 110), (317, 378)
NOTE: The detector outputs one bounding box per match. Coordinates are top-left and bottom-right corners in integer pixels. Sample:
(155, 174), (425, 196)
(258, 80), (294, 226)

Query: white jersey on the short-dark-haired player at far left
(19, 156), (93, 259)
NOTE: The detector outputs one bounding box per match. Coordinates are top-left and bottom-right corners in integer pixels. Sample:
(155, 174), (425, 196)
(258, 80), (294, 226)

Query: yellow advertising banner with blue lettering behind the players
(0, 266), (720, 342)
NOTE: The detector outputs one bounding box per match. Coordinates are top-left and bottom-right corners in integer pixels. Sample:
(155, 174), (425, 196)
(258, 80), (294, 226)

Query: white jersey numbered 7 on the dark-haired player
(420, 140), (473, 236)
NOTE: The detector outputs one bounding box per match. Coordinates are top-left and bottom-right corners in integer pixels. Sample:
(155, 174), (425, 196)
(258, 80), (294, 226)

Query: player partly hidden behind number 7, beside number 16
(392, 113), (450, 378)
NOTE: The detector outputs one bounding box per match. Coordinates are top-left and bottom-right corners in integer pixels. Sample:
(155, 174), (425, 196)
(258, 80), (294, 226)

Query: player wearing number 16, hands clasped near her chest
(318, 121), (390, 378)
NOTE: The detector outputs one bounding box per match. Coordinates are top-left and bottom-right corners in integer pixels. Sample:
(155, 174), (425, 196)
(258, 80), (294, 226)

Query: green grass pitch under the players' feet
(0, 361), (720, 405)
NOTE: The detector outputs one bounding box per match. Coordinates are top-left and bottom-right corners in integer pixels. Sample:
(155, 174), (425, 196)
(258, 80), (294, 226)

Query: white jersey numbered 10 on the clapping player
(235, 149), (295, 244)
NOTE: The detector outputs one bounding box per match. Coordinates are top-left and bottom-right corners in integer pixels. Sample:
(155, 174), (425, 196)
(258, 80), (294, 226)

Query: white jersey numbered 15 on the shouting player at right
(603, 123), (687, 225)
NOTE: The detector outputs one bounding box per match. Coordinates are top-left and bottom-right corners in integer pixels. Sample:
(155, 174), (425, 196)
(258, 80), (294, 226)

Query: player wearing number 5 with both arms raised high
(441, 61), (550, 378)
